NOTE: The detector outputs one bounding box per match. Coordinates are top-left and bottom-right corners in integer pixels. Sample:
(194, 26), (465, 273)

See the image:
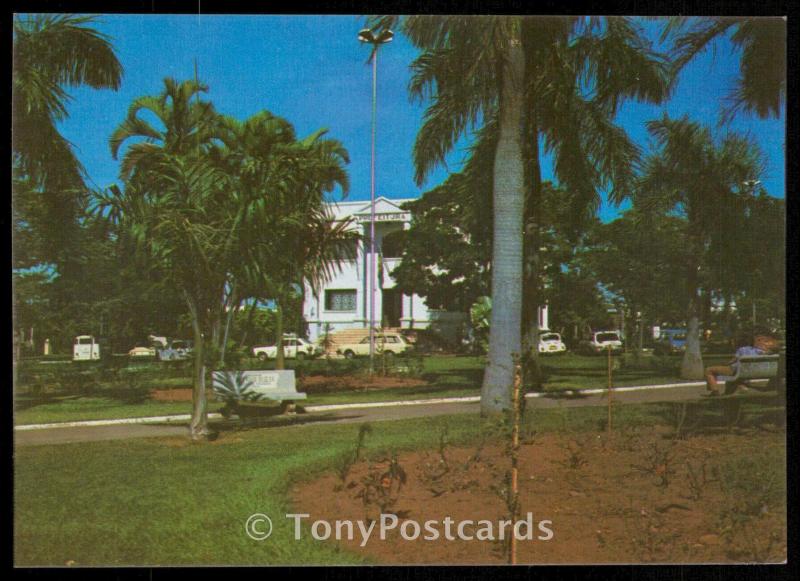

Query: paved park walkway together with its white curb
(14, 382), (720, 446)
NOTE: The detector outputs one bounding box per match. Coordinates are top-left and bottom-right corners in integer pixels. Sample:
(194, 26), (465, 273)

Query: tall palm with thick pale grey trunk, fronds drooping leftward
(403, 16), (526, 413)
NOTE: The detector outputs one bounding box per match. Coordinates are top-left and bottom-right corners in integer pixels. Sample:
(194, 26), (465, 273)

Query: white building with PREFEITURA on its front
(303, 197), (465, 341)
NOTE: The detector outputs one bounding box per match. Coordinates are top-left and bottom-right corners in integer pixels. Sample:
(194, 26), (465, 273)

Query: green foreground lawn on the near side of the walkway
(14, 396), (782, 566)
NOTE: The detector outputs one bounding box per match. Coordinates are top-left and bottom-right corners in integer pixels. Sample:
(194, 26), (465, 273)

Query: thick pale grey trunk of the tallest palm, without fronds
(481, 31), (525, 414)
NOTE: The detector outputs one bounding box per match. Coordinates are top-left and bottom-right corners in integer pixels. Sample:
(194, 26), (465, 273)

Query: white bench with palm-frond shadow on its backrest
(212, 369), (307, 417)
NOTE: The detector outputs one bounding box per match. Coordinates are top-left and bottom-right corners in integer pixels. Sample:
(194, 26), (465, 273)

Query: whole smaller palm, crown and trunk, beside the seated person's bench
(636, 116), (764, 379)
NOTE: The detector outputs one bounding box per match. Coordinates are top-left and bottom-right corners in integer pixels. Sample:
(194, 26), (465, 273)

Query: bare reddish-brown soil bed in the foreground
(293, 428), (787, 564)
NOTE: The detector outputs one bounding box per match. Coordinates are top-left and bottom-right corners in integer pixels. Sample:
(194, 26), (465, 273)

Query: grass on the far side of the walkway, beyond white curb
(15, 353), (727, 425)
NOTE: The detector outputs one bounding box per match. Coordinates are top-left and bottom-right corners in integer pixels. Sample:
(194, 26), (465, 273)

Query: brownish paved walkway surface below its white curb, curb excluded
(14, 385), (752, 446)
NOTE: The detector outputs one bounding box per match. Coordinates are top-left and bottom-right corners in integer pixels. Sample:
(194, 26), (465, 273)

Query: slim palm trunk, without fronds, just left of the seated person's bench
(681, 200), (704, 379)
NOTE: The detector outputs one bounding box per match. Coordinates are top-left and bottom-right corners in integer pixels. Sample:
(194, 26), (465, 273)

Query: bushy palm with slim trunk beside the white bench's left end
(96, 154), (234, 439)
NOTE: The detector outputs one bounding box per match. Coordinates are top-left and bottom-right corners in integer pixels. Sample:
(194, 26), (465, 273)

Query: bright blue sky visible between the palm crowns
(61, 15), (785, 220)
